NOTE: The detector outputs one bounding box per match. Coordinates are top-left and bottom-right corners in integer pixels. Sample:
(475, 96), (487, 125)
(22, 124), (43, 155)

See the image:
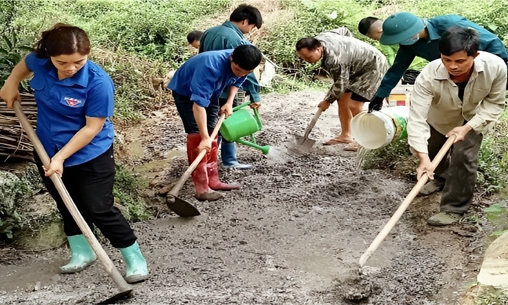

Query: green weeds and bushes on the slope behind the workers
(0, 0), (508, 120)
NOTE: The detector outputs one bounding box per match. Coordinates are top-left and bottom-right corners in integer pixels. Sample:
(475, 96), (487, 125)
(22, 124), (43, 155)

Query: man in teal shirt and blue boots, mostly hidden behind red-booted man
(199, 4), (263, 169)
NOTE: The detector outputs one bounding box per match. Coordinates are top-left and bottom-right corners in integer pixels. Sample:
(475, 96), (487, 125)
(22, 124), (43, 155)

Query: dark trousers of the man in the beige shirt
(428, 126), (483, 214)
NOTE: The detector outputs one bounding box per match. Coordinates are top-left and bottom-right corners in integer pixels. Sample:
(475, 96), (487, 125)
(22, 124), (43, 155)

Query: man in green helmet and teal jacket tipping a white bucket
(366, 12), (508, 112)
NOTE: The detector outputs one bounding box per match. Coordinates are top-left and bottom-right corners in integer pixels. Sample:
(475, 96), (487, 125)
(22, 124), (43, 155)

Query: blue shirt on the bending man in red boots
(168, 50), (245, 108)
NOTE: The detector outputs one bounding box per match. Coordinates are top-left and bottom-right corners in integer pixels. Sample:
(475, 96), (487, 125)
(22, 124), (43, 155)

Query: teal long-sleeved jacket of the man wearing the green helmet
(376, 15), (508, 98)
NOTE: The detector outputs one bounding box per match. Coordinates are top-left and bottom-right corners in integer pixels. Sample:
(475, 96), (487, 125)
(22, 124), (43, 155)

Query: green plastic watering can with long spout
(220, 102), (270, 155)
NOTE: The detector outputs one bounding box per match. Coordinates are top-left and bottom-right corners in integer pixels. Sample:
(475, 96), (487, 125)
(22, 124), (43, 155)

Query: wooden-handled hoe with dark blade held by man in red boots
(166, 114), (226, 217)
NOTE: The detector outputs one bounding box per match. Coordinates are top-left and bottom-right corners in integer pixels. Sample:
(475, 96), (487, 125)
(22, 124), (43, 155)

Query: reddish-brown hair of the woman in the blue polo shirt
(35, 23), (90, 58)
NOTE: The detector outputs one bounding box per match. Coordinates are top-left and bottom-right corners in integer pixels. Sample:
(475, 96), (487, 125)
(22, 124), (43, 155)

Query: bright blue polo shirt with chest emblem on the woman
(25, 53), (114, 166)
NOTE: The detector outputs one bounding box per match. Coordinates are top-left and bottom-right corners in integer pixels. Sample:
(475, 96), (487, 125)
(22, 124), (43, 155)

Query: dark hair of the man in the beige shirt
(439, 26), (480, 56)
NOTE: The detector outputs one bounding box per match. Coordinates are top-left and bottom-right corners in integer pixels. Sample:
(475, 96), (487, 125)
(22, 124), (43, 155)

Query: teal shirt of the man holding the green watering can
(199, 21), (261, 102)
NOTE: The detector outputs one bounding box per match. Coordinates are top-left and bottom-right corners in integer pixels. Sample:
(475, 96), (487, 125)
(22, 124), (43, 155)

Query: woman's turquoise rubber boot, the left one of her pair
(60, 234), (97, 273)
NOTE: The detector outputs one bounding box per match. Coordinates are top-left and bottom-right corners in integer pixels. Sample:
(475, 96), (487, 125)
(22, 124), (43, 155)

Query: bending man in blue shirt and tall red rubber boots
(168, 45), (261, 201)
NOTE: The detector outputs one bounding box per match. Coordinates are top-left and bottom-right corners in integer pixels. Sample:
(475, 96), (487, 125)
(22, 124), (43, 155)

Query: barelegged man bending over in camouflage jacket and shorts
(296, 27), (388, 151)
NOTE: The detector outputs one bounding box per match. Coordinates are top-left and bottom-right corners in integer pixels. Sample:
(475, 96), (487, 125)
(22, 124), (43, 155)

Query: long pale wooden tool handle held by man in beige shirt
(359, 136), (455, 267)
